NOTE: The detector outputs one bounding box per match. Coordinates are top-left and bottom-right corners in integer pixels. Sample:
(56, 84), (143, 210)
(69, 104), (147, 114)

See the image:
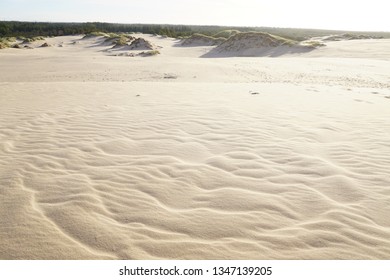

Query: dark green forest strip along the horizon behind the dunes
(0, 21), (390, 41)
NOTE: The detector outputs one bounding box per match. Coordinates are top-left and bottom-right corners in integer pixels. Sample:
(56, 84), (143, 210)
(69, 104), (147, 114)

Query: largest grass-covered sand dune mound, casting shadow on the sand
(205, 32), (313, 57)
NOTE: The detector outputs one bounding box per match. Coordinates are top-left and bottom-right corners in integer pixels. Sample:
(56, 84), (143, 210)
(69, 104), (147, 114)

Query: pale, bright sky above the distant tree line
(0, 0), (390, 31)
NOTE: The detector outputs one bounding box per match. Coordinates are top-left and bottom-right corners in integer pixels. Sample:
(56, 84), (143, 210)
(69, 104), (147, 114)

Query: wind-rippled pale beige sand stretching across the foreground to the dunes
(0, 35), (390, 259)
